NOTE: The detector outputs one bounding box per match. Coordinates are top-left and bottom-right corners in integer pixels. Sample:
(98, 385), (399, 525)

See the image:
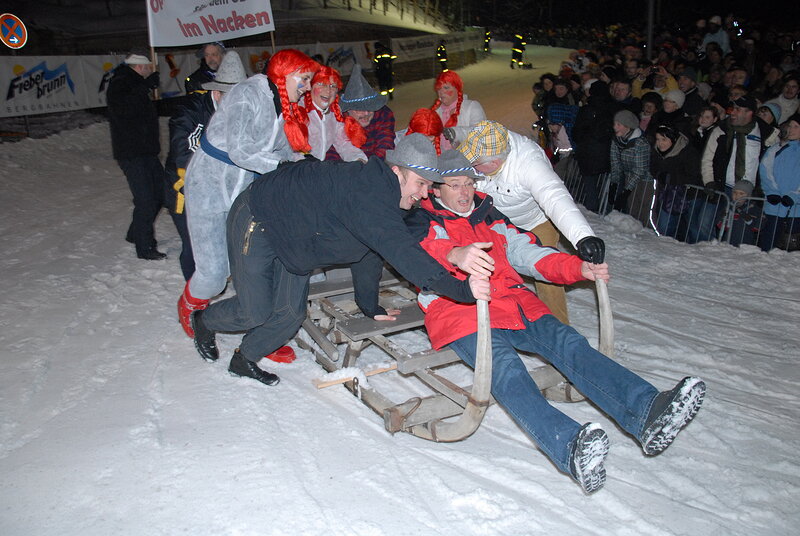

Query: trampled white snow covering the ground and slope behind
(0, 47), (800, 536)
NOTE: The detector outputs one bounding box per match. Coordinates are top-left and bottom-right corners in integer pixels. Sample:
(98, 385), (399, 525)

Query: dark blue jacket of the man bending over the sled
(250, 157), (475, 316)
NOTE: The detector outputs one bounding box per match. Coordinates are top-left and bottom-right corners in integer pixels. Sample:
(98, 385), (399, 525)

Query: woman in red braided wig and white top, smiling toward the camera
(305, 65), (367, 162)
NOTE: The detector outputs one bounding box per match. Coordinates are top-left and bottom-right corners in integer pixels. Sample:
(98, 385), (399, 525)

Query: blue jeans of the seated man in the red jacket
(450, 315), (658, 474)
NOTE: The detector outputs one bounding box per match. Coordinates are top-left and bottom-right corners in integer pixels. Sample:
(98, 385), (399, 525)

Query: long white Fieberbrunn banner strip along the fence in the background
(0, 30), (483, 117)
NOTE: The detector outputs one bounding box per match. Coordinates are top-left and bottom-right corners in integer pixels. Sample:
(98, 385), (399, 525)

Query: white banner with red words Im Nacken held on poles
(145, 0), (275, 47)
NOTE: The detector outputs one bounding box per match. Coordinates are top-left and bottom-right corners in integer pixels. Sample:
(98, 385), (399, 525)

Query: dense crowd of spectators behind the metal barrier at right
(520, 15), (800, 251)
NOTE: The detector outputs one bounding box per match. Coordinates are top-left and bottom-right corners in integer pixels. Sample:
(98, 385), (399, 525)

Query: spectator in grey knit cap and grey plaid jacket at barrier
(609, 110), (652, 225)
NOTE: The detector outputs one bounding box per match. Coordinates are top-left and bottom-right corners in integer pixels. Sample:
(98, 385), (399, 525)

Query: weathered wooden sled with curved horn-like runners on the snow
(295, 270), (614, 442)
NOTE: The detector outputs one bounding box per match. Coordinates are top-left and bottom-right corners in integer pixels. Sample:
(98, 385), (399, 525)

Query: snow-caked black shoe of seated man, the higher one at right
(639, 377), (706, 456)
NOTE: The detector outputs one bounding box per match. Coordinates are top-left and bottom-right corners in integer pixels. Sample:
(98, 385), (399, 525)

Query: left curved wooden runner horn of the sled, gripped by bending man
(414, 300), (492, 442)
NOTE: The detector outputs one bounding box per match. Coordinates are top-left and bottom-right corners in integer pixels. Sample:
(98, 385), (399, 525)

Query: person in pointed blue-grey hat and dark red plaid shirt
(325, 64), (394, 160)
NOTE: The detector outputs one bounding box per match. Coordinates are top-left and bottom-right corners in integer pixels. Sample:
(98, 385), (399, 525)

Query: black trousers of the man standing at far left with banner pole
(117, 156), (164, 254)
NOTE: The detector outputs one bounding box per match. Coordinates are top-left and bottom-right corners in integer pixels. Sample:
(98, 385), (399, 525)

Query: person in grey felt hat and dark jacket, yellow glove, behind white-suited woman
(164, 51), (247, 281)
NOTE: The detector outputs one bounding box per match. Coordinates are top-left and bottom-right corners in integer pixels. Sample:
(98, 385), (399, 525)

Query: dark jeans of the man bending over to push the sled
(203, 188), (310, 361)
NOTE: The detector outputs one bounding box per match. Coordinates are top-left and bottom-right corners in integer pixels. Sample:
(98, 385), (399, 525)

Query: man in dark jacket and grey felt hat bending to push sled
(192, 134), (484, 385)
